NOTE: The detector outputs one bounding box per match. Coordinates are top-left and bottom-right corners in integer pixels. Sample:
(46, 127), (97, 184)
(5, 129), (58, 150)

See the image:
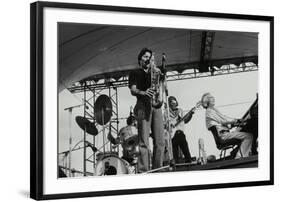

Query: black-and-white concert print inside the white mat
(58, 23), (259, 177)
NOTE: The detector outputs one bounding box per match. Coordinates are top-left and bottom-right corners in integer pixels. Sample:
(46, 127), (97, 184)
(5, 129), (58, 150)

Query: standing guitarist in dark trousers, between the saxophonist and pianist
(165, 96), (194, 163)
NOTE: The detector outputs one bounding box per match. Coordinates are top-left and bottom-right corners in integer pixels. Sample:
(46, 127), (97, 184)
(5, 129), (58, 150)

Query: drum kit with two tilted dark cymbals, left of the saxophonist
(75, 95), (138, 176)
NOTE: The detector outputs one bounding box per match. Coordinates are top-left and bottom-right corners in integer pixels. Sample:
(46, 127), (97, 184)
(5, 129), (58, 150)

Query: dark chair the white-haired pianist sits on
(209, 126), (243, 159)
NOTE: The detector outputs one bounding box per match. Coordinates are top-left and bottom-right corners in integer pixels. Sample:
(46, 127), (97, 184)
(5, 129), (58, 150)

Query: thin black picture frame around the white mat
(30, 2), (274, 200)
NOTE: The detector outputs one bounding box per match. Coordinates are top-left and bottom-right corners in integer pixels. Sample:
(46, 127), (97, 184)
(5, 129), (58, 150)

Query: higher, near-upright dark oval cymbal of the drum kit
(94, 95), (112, 125)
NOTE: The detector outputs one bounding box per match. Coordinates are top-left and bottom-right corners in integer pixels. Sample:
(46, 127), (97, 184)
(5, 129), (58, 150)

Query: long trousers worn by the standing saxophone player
(134, 102), (165, 173)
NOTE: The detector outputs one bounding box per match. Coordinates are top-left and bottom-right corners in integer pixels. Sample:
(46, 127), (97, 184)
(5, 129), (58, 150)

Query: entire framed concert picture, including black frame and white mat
(30, 2), (274, 200)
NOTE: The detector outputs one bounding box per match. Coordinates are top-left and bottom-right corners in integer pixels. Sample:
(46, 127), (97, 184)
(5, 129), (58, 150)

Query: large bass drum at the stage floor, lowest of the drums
(95, 155), (133, 176)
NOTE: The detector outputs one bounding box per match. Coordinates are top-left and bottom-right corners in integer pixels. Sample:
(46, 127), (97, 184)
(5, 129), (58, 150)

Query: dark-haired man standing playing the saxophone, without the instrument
(129, 48), (165, 173)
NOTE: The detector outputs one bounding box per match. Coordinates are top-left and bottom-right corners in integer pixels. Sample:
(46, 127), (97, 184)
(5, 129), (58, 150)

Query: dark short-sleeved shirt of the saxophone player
(129, 68), (151, 102)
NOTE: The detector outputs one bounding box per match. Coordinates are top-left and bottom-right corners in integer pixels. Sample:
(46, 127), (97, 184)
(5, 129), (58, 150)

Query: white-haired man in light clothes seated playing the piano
(201, 93), (253, 158)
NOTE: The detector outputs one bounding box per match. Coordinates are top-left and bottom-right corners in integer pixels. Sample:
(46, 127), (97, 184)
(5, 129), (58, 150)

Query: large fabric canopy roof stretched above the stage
(59, 23), (258, 91)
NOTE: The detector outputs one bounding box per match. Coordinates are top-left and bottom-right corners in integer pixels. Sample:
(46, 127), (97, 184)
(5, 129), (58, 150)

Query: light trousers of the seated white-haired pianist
(220, 131), (253, 158)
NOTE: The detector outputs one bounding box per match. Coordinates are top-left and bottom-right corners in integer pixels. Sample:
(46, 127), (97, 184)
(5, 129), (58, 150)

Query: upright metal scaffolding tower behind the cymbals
(77, 81), (119, 175)
